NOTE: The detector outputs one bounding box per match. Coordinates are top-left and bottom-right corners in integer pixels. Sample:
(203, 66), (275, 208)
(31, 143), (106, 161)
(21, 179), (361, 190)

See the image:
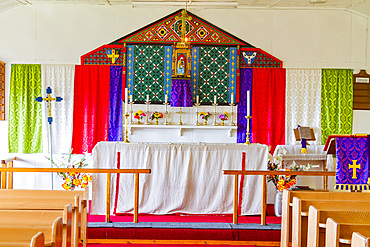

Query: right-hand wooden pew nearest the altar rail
(280, 190), (370, 247)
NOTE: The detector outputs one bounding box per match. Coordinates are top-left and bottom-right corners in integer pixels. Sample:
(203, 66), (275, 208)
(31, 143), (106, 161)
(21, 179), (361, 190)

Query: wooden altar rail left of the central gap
(0, 161), (151, 223)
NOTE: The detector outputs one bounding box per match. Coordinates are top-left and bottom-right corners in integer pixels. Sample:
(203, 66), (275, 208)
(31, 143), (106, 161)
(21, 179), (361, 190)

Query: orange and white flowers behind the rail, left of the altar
(49, 150), (92, 190)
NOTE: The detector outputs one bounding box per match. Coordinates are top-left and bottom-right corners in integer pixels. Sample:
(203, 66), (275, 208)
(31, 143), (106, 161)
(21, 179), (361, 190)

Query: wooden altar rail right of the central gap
(223, 170), (335, 225)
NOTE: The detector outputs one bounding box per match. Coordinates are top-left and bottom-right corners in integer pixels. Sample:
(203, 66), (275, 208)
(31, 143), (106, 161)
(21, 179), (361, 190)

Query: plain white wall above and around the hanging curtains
(0, 4), (370, 192)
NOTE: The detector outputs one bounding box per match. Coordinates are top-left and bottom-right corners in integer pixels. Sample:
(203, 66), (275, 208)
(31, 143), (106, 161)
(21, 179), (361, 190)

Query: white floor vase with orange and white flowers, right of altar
(267, 149), (311, 217)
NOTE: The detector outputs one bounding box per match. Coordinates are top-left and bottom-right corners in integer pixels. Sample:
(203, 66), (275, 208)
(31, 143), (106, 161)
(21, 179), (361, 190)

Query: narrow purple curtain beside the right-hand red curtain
(237, 69), (253, 143)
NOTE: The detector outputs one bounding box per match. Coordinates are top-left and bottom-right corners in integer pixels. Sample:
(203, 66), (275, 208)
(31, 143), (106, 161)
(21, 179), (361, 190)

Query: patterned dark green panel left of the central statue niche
(133, 45), (165, 102)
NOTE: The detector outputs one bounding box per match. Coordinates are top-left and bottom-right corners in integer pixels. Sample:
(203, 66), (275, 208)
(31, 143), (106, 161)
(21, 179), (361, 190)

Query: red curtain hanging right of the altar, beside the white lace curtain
(252, 68), (285, 153)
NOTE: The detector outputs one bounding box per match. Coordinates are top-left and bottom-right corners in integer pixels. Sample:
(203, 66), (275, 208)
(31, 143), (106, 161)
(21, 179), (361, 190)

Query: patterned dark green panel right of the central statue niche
(198, 46), (230, 104)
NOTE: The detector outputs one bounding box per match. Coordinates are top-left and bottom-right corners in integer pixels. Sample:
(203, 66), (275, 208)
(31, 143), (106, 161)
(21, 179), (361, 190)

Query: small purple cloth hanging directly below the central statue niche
(171, 79), (193, 107)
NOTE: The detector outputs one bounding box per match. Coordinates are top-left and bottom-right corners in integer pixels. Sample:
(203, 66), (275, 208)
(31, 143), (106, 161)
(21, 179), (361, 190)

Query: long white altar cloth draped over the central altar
(91, 142), (268, 215)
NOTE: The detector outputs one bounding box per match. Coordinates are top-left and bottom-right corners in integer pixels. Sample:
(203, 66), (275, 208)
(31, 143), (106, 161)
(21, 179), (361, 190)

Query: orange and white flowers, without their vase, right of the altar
(267, 150), (312, 191)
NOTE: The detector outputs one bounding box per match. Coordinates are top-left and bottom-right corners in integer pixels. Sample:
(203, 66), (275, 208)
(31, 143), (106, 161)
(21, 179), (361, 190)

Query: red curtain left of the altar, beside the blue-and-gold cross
(72, 65), (110, 153)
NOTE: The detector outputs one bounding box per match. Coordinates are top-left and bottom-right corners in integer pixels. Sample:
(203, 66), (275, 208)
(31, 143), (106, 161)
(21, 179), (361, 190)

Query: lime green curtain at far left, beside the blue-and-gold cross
(8, 64), (42, 153)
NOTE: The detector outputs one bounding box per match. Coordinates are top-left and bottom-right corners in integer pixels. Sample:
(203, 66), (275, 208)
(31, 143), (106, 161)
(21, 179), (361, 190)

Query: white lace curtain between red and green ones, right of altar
(285, 69), (321, 145)
